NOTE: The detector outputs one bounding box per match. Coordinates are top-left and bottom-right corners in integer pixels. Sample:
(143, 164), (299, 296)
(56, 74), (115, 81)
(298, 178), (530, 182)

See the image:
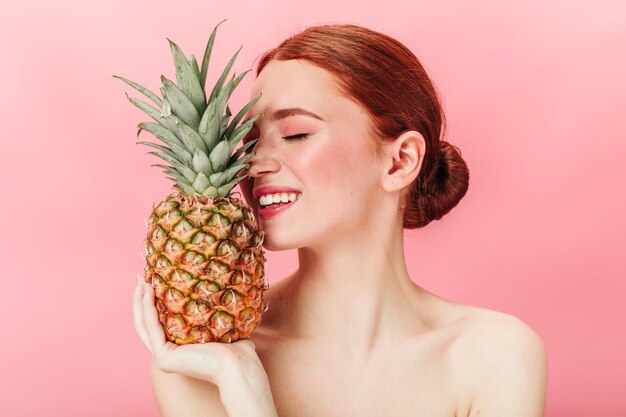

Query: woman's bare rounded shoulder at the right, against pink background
(454, 307), (548, 417)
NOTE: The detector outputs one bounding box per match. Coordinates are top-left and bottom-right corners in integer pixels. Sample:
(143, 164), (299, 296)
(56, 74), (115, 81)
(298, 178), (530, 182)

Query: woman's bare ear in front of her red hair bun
(382, 130), (426, 192)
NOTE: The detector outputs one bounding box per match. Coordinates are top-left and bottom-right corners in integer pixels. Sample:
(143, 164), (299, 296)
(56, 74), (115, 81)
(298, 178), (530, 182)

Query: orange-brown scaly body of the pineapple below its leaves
(144, 191), (268, 345)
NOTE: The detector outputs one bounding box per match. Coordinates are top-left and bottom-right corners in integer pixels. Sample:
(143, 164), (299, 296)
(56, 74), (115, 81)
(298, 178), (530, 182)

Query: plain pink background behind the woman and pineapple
(0, 0), (626, 417)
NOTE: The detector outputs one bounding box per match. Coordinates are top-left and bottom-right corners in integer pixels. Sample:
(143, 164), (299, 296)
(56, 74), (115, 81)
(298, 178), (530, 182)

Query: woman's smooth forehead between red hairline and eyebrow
(250, 59), (341, 113)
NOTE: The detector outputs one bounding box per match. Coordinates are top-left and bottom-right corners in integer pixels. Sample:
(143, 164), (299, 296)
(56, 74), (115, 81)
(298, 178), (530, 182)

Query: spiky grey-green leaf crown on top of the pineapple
(113, 20), (261, 198)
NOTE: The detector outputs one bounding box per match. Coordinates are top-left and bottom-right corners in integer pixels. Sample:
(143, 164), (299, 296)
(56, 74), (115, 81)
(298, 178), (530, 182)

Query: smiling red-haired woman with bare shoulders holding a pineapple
(135, 25), (547, 417)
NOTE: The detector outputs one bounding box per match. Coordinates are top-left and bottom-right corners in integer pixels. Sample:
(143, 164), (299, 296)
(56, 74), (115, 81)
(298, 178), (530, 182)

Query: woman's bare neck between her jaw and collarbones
(266, 214), (421, 356)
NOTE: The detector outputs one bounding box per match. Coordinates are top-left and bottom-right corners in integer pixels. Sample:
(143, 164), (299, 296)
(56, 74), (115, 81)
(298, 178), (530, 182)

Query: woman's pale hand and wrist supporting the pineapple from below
(133, 275), (276, 416)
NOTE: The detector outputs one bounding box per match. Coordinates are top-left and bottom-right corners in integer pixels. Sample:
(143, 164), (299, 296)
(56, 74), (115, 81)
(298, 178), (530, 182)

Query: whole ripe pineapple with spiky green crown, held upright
(113, 23), (268, 345)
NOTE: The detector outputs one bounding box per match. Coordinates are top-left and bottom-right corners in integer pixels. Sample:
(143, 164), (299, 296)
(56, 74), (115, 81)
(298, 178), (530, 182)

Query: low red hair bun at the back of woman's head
(403, 140), (469, 229)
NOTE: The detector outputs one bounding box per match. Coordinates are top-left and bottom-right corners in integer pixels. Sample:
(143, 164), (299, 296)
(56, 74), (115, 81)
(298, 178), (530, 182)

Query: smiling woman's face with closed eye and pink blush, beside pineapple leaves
(240, 60), (382, 250)
